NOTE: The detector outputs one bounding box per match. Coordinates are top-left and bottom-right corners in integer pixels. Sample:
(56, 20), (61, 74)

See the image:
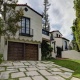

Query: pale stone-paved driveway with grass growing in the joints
(0, 61), (78, 80)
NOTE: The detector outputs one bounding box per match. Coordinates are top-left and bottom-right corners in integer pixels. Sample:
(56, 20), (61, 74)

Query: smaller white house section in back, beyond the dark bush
(50, 30), (69, 57)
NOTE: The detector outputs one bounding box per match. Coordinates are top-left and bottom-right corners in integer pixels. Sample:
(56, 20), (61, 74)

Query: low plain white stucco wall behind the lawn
(62, 50), (80, 60)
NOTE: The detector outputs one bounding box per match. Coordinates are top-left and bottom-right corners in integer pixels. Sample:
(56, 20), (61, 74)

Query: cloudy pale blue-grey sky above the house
(18, 0), (76, 40)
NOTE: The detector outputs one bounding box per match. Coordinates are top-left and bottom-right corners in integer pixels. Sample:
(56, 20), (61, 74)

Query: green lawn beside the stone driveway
(51, 60), (80, 78)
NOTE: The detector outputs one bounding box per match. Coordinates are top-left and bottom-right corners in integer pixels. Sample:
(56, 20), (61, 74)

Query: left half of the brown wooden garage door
(8, 42), (24, 60)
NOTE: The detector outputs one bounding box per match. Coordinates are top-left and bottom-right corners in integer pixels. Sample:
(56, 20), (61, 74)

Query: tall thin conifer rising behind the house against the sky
(43, 0), (50, 31)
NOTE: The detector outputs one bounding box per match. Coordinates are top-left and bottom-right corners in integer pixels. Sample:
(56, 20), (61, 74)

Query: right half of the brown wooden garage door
(25, 44), (38, 60)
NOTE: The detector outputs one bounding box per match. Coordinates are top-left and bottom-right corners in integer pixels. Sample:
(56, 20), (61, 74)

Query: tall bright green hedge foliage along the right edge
(72, 0), (80, 50)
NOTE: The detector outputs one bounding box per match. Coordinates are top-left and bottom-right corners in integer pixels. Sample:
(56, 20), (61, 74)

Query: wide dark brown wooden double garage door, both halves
(8, 41), (38, 61)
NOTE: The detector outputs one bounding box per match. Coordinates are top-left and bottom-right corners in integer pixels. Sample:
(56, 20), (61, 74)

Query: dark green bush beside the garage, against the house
(41, 41), (53, 59)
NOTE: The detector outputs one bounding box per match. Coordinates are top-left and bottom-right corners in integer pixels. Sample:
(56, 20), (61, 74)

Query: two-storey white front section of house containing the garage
(1, 4), (43, 61)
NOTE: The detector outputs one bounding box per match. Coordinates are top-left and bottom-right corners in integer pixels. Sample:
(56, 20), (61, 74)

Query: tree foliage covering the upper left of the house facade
(0, 0), (23, 36)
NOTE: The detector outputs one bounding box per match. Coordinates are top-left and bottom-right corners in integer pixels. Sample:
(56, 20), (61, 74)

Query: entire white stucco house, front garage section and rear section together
(0, 4), (69, 61)
